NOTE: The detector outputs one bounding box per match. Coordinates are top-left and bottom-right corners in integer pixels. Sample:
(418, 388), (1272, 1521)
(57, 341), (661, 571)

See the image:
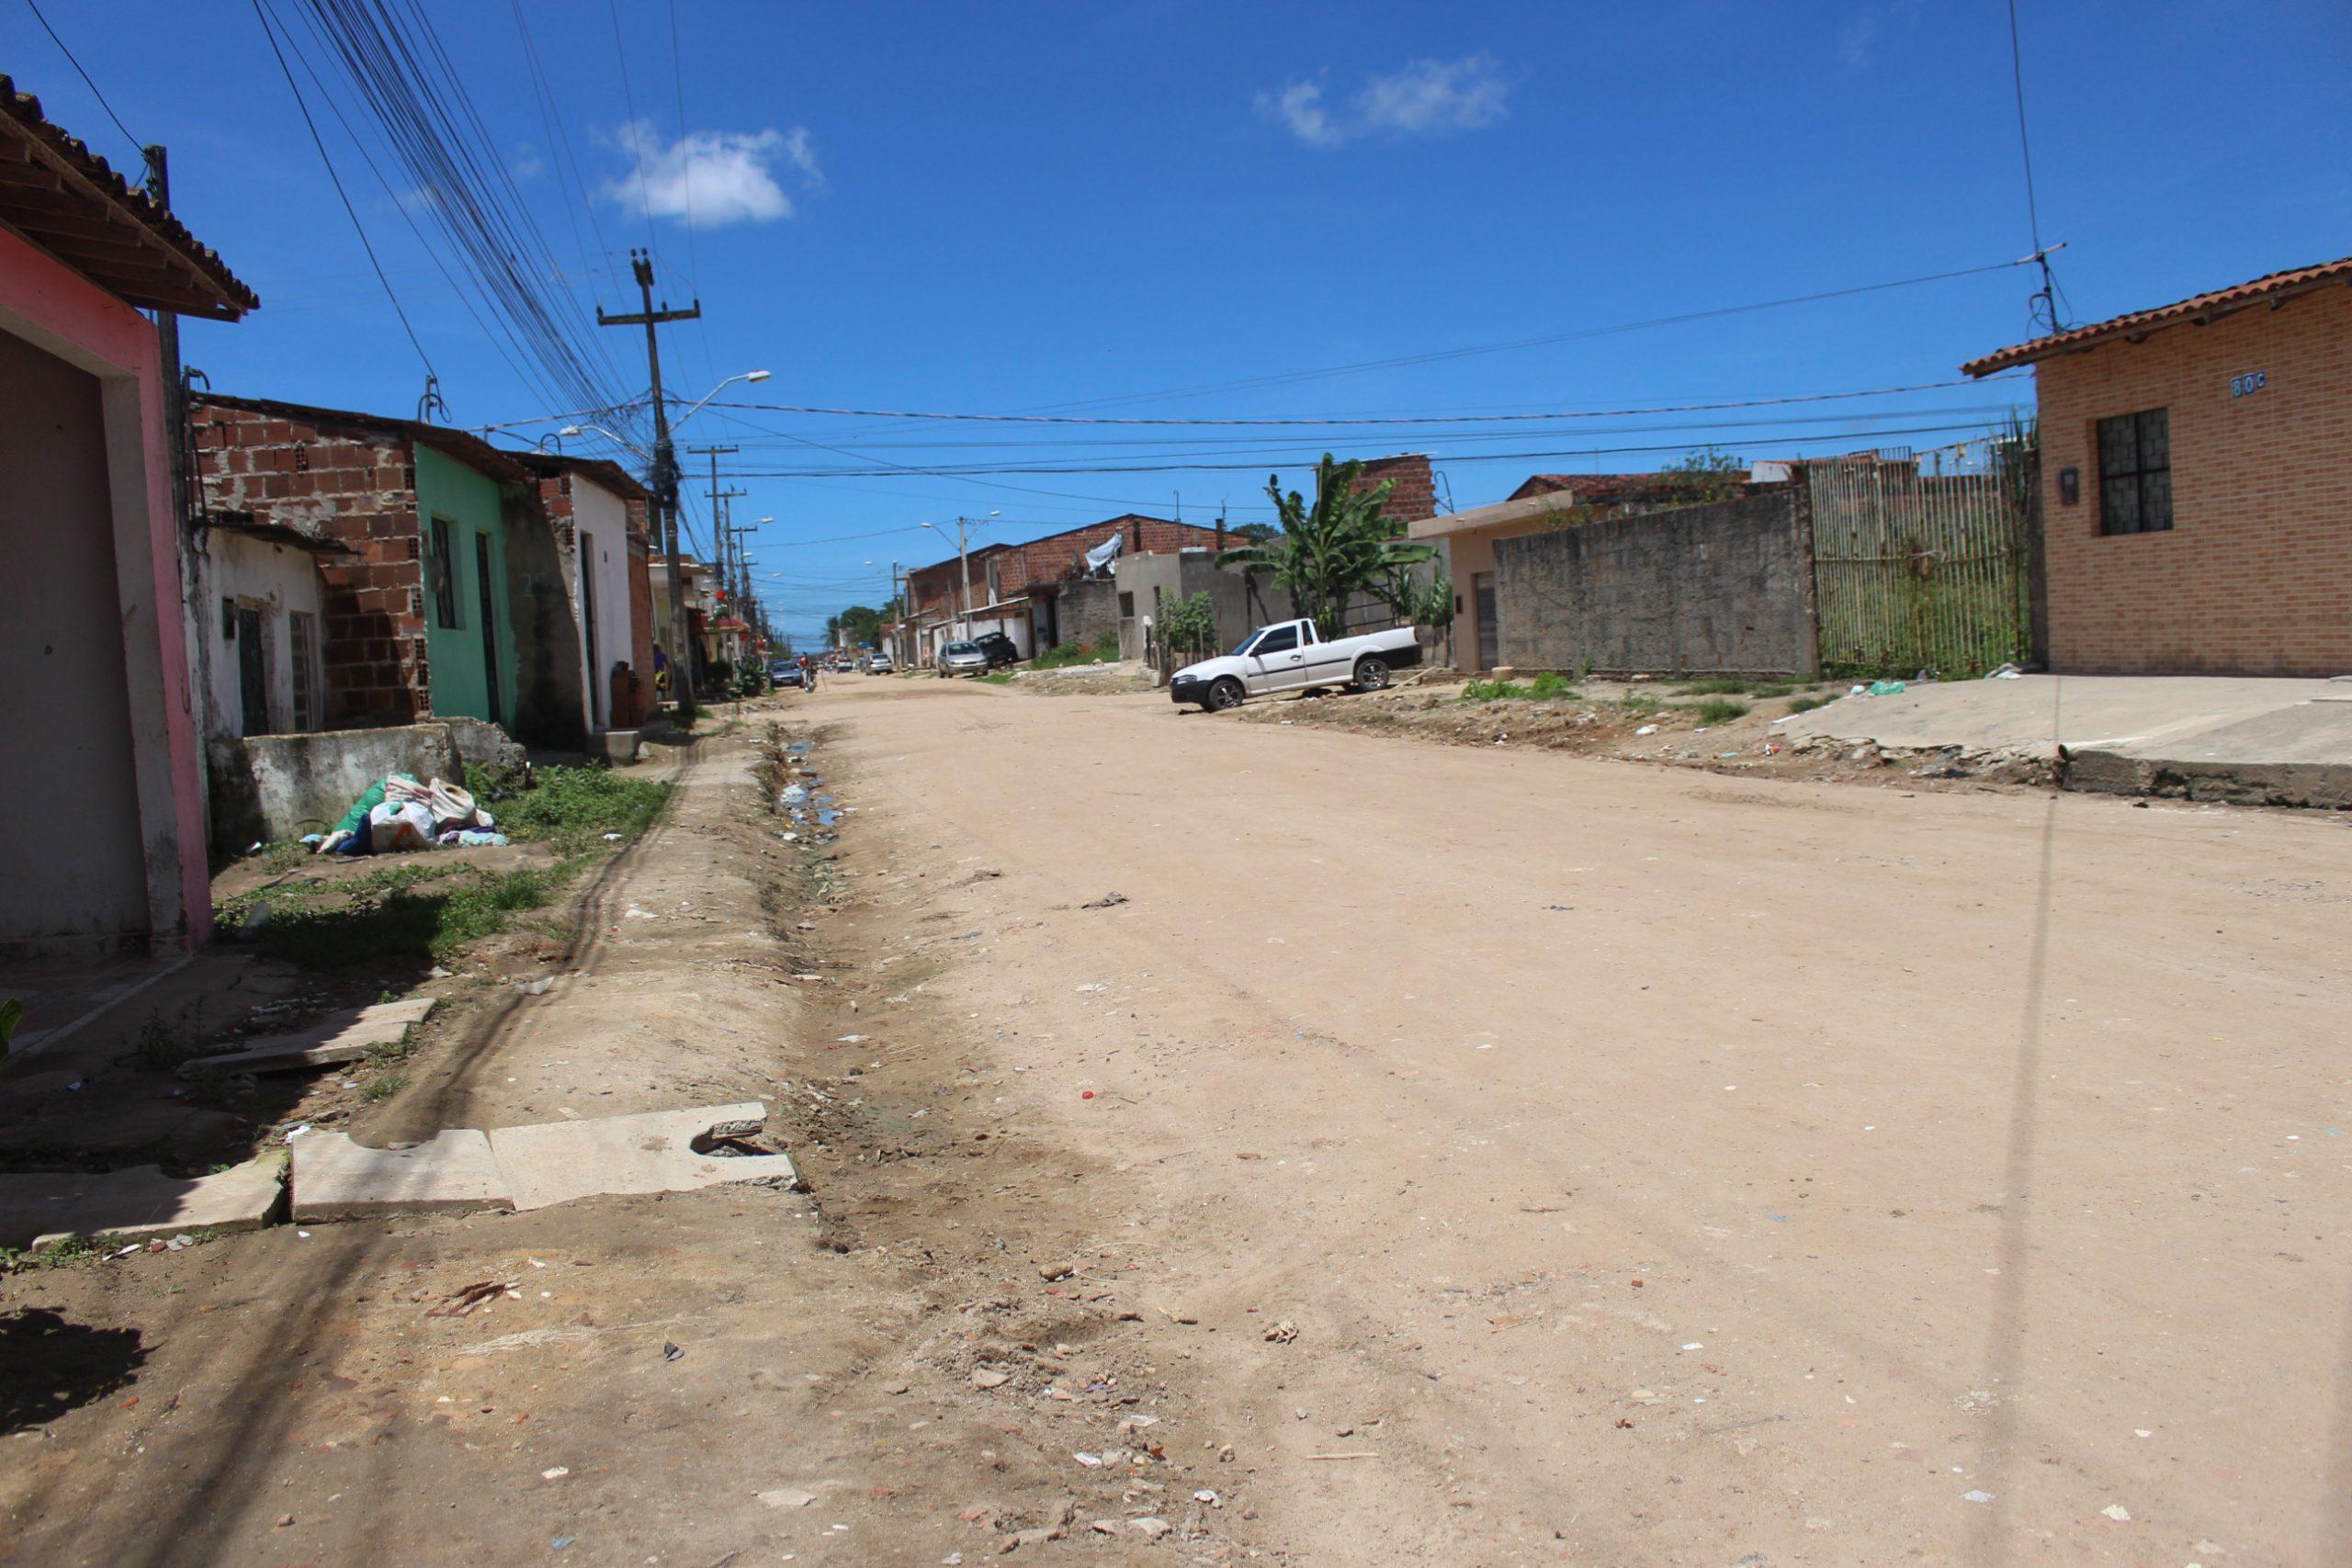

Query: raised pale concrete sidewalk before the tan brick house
(1781, 674), (2352, 807)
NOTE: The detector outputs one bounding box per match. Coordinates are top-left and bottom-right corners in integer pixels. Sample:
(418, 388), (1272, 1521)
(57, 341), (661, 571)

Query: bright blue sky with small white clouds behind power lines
(0, 0), (2352, 632)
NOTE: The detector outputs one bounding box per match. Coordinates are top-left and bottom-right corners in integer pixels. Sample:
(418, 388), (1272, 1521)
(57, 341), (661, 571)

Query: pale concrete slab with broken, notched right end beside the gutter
(489, 1100), (799, 1208)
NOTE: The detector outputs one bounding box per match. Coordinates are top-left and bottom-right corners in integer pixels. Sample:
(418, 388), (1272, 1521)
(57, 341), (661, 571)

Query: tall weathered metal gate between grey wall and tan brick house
(1804, 433), (2034, 677)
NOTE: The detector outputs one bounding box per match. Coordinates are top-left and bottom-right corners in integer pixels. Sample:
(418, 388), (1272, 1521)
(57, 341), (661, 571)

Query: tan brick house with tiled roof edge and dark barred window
(1962, 259), (2352, 674)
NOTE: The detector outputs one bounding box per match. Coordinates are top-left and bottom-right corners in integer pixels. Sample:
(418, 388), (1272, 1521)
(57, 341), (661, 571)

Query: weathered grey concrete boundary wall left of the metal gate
(1494, 487), (1820, 674)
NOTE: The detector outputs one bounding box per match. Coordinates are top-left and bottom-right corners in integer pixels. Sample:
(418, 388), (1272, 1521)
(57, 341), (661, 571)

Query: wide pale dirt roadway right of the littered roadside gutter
(805, 682), (2352, 1568)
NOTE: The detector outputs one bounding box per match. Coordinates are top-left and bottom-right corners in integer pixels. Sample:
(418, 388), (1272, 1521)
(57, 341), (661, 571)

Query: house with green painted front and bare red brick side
(188, 392), (585, 750)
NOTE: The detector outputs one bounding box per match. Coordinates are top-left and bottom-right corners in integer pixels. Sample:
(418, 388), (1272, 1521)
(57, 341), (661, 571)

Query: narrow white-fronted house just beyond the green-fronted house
(515, 451), (654, 736)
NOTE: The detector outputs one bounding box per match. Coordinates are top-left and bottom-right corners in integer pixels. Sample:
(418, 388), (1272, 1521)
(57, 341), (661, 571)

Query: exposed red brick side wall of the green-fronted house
(188, 400), (433, 728)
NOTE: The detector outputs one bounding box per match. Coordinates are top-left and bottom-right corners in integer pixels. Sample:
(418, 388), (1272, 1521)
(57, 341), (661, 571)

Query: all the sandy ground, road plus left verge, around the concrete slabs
(0, 682), (2352, 1568)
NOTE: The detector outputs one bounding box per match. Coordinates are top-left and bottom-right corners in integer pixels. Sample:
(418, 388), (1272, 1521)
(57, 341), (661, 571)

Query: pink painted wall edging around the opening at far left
(0, 228), (211, 947)
